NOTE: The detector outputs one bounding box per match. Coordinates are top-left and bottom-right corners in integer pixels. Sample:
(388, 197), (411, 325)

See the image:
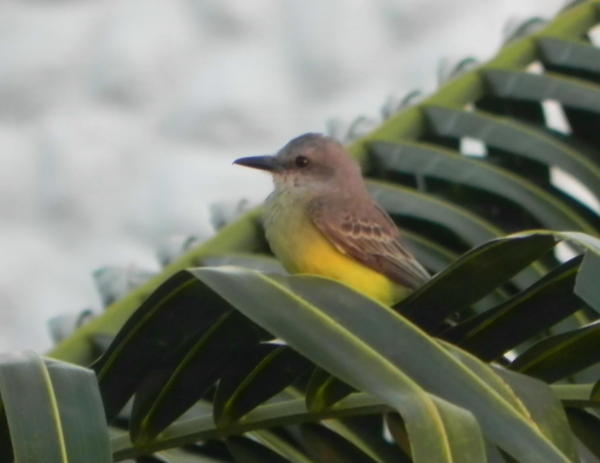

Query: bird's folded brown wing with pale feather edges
(308, 198), (429, 289)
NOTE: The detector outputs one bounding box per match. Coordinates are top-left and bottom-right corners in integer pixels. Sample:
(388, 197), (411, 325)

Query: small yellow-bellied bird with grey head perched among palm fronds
(234, 133), (430, 306)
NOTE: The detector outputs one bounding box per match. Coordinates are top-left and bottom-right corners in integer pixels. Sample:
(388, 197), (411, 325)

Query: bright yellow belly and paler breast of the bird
(266, 205), (409, 305)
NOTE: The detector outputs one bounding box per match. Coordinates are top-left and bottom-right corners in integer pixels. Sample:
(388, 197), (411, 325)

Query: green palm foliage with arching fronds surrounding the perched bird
(0, 0), (600, 463)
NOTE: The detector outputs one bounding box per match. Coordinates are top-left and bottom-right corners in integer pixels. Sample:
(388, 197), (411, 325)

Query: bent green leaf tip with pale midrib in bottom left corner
(0, 352), (112, 463)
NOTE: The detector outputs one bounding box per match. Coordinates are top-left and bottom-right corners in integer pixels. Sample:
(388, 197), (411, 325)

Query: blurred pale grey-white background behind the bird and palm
(0, 0), (564, 352)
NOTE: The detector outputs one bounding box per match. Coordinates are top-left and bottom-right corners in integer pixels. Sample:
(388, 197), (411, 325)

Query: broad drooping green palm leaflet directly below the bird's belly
(193, 269), (564, 461)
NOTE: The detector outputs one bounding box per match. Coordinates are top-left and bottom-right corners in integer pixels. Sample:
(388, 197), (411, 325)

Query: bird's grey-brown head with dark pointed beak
(234, 133), (364, 194)
